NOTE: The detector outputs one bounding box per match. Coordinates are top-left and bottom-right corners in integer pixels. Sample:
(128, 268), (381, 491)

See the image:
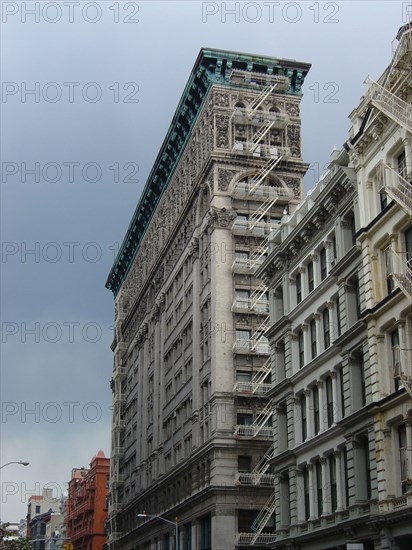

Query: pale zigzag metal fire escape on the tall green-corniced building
(232, 77), (292, 545)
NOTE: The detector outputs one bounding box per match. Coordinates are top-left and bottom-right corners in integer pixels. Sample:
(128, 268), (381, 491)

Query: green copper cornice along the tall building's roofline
(106, 48), (310, 296)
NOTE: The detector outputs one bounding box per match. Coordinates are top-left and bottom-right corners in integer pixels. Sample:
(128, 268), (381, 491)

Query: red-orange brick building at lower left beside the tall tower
(66, 450), (110, 550)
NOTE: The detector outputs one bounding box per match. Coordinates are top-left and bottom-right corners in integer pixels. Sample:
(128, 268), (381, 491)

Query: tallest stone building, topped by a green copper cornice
(106, 49), (310, 550)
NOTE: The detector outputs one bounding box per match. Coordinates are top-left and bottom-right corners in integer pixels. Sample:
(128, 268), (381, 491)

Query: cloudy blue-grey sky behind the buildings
(0, 0), (406, 521)
